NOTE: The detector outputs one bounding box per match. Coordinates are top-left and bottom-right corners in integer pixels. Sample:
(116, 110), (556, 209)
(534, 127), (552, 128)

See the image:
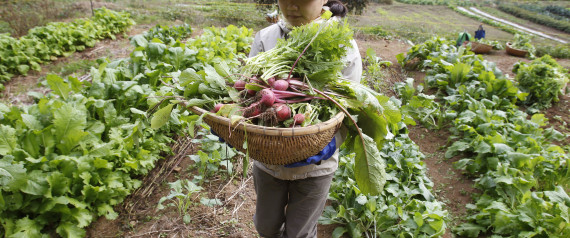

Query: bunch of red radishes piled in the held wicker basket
(214, 76), (322, 127)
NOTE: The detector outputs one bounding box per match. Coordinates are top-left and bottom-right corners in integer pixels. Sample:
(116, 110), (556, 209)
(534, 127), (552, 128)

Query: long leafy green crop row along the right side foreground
(398, 38), (570, 237)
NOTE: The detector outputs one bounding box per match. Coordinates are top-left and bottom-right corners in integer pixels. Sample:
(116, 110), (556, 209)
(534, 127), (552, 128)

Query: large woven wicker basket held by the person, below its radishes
(188, 107), (344, 165)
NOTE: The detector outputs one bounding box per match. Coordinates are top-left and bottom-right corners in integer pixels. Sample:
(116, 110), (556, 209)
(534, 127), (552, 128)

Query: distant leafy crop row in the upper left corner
(0, 8), (134, 90)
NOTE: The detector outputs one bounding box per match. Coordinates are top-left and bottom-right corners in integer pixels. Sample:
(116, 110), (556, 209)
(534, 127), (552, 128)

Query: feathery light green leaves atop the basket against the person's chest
(243, 17), (353, 89)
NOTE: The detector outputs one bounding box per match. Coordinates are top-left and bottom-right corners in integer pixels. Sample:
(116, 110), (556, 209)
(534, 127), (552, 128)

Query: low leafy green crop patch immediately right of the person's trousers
(319, 123), (448, 237)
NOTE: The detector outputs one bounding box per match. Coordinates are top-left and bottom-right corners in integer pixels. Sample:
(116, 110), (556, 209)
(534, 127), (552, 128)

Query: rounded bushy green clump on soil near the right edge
(513, 55), (569, 109)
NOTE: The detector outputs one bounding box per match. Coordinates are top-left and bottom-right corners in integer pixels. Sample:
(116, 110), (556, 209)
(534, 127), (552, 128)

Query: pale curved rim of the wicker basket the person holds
(181, 103), (344, 136)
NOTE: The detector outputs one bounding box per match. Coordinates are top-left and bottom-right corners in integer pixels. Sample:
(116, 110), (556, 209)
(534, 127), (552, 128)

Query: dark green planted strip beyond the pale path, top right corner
(499, 4), (570, 33)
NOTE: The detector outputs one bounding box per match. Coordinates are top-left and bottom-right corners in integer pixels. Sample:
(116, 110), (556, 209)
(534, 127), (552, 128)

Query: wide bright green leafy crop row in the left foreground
(0, 23), (248, 237)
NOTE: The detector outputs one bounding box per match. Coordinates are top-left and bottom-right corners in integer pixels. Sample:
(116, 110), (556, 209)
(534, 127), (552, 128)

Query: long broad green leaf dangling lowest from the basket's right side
(354, 135), (386, 196)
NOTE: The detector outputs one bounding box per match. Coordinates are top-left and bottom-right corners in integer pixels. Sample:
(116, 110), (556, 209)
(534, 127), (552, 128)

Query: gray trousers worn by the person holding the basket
(253, 166), (333, 238)
